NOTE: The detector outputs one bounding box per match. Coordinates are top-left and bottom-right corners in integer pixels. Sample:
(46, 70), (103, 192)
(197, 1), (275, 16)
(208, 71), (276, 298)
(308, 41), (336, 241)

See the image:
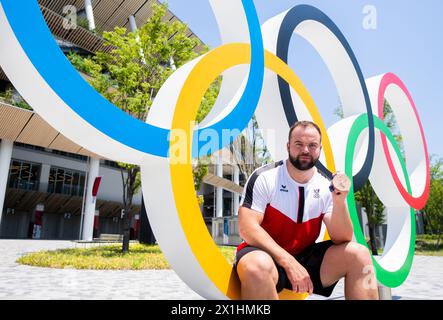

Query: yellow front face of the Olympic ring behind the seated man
(170, 44), (335, 300)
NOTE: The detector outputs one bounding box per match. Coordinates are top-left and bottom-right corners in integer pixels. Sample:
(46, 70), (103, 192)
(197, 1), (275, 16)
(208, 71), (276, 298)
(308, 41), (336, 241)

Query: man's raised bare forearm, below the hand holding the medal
(323, 190), (354, 244)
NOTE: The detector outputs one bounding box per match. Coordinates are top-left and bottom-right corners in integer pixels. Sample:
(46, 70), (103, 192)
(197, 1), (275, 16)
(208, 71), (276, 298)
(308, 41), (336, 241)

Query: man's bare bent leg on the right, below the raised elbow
(320, 242), (378, 300)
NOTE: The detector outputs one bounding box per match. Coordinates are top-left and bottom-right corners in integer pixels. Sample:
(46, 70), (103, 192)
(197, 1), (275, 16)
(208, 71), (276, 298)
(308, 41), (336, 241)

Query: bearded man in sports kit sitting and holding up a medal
(234, 121), (378, 300)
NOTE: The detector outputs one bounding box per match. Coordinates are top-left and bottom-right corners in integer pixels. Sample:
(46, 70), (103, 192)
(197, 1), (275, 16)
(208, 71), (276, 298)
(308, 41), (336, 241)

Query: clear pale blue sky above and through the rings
(162, 0), (443, 157)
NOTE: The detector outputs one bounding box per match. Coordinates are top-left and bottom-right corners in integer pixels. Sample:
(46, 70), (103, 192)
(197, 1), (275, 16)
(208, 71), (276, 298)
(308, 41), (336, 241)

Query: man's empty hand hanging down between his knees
(278, 254), (314, 294)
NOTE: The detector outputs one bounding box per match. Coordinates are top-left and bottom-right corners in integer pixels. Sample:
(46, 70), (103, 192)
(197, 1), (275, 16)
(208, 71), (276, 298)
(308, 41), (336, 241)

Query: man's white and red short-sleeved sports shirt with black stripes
(237, 161), (332, 255)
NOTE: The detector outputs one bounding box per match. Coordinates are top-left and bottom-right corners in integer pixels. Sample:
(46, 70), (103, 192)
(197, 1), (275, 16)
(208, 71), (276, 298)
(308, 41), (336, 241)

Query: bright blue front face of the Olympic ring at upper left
(1, 0), (264, 157)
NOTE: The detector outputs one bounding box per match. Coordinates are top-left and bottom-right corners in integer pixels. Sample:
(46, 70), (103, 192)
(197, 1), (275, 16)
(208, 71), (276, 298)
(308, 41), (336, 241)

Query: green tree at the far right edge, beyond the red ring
(423, 155), (443, 248)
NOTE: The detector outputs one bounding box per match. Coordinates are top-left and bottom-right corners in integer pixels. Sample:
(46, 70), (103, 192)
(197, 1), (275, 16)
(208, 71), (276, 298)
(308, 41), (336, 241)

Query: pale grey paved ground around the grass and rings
(0, 240), (443, 300)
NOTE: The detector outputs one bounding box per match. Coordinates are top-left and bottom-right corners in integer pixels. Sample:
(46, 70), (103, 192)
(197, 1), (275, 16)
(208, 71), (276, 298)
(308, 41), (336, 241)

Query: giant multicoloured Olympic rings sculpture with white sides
(0, 0), (430, 299)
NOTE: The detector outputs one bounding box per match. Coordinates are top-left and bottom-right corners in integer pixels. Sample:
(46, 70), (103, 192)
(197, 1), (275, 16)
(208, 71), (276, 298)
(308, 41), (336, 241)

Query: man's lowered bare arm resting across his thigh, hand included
(238, 207), (314, 294)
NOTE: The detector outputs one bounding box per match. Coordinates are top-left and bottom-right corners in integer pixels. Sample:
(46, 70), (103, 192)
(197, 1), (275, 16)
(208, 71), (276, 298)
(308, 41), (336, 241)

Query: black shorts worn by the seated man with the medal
(234, 240), (338, 297)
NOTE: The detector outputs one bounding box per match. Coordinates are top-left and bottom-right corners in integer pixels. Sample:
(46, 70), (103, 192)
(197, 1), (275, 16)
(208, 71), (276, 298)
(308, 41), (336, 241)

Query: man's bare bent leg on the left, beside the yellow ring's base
(237, 250), (278, 300)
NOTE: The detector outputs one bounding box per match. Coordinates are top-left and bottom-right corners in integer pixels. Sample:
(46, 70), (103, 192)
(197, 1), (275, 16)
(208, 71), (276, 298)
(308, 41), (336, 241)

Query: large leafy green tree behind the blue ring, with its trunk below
(68, 4), (209, 252)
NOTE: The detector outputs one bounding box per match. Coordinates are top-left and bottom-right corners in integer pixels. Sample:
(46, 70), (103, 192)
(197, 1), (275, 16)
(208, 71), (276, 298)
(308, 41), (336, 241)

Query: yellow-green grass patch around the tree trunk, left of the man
(16, 243), (235, 270)
